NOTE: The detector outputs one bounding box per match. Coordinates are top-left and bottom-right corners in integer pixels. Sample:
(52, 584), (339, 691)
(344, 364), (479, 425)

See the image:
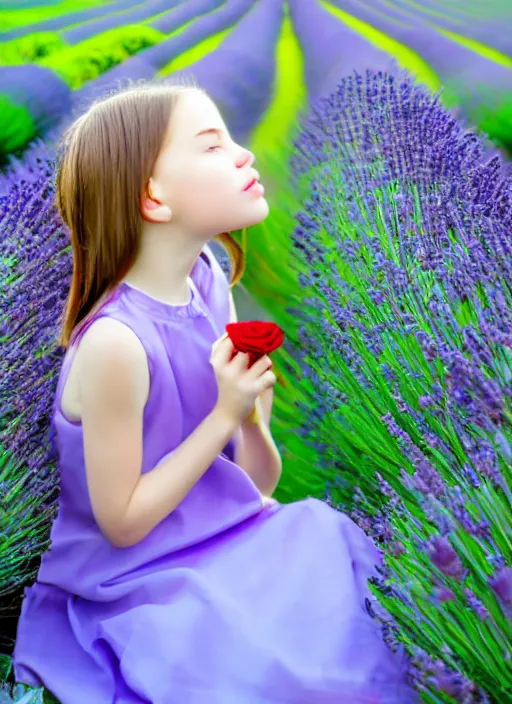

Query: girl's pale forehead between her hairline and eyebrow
(169, 90), (226, 142)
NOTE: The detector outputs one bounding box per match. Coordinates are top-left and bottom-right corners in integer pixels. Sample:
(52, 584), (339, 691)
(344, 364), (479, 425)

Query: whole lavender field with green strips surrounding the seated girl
(0, 0), (512, 704)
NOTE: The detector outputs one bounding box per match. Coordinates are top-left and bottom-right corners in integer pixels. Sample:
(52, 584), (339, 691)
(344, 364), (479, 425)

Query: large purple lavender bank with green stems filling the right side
(291, 72), (512, 704)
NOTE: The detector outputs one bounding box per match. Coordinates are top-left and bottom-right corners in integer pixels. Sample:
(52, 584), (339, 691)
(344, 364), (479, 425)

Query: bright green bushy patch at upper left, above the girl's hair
(37, 24), (165, 90)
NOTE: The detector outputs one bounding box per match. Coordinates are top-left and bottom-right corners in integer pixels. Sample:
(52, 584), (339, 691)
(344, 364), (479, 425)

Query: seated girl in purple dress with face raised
(14, 85), (415, 704)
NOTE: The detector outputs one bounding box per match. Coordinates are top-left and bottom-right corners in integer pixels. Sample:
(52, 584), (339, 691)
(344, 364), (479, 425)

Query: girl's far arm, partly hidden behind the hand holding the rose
(229, 293), (282, 496)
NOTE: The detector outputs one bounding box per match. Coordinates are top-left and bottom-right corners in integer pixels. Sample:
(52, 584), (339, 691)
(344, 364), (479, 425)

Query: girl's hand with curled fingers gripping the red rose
(210, 334), (276, 424)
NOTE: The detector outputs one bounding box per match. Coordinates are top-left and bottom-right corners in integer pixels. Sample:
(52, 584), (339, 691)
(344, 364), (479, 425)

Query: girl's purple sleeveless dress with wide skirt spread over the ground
(14, 247), (417, 704)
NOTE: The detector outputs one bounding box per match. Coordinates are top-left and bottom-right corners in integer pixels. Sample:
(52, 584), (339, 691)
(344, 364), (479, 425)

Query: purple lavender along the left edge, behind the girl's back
(0, 145), (71, 624)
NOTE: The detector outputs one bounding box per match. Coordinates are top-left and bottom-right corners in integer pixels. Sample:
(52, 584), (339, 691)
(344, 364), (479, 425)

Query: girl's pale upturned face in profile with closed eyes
(150, 90), (269, 237)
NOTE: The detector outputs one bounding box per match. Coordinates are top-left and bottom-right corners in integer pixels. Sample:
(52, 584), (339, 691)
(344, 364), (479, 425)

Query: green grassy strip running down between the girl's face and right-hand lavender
(243, 13), (316, 503)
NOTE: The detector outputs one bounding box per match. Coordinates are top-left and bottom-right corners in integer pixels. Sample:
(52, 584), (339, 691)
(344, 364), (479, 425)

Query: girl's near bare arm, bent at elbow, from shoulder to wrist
(77, 318), (236, 547)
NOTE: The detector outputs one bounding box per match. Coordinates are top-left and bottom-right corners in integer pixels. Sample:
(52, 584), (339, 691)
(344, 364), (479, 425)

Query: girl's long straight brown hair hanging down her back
(56, 84), (245, 347)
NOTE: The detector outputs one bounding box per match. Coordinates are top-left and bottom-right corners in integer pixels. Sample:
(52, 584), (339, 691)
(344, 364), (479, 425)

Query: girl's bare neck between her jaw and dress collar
(123, 225), (205, 305)
